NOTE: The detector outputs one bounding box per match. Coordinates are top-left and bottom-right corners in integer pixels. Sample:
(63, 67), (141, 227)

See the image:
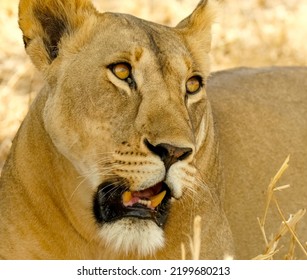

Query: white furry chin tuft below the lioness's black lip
(100, 218), (164, 258)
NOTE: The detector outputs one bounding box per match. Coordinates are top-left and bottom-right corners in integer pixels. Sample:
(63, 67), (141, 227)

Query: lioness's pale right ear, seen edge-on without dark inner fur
(175, 0), (218, 54)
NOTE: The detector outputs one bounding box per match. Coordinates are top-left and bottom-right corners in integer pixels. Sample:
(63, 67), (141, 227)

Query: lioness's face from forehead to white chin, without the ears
(21, 1), (217, 255)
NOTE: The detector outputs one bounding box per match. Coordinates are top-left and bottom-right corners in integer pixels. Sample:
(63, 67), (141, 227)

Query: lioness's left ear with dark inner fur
(19, 0), (97, 70)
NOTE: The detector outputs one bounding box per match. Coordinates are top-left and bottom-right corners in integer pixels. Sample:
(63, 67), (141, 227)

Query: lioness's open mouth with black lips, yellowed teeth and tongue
(93, 182), (171, 227)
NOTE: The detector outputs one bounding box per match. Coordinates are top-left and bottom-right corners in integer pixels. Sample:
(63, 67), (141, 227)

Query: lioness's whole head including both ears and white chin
(0, 0), (233, 256)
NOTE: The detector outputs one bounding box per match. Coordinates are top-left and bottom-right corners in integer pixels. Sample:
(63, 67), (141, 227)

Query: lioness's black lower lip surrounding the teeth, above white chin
(93, 182), (171, 227)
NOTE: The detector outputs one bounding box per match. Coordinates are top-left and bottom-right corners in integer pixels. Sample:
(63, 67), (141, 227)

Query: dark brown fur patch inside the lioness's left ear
(34, 8), (68, 61)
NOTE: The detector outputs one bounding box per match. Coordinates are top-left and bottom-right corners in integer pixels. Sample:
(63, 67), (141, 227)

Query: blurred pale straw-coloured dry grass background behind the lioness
(0, 0), (307, 172)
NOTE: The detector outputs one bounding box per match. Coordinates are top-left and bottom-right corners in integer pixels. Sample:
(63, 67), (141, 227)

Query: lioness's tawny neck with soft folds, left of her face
(0, 91), (105, 259)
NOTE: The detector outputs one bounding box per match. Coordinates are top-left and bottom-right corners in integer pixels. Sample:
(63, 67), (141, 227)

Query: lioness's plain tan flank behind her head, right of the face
(207, 67), (307, 259)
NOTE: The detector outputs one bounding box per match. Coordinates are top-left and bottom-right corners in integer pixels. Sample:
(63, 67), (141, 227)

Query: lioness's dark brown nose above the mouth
(144, 139), (193, 170)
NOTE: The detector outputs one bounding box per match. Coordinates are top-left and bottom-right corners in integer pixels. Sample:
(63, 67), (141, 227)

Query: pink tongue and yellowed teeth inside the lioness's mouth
(122, 186), (166, 208)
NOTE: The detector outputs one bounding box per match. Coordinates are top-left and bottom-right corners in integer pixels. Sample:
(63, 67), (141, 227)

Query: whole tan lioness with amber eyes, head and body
(0, 0), (307, 259)
